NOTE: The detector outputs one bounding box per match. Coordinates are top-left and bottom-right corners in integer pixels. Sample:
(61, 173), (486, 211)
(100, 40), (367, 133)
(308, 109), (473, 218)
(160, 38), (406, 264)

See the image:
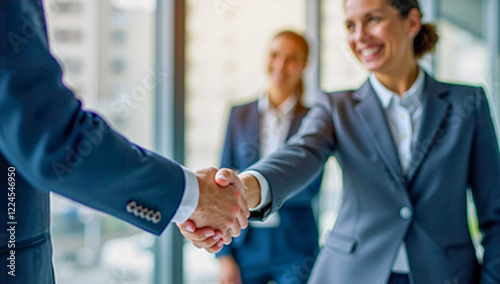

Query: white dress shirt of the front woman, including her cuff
(245, 68), (425, 274)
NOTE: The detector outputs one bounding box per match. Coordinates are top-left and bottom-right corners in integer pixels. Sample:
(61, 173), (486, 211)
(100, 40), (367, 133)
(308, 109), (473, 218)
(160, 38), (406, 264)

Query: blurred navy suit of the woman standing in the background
(217, 101), (322, 284)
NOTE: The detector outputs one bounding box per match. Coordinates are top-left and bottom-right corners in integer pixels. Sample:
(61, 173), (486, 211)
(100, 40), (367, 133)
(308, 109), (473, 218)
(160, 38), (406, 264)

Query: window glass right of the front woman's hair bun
(436, 0), (493, 258)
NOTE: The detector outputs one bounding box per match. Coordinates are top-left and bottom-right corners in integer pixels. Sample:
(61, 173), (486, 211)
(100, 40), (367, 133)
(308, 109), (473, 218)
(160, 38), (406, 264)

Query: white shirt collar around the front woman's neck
(369, 67), (425, 109)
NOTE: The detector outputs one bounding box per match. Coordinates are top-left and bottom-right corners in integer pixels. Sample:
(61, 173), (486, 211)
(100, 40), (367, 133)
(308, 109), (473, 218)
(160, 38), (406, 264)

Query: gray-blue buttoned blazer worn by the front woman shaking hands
(250, 74), (500, 284)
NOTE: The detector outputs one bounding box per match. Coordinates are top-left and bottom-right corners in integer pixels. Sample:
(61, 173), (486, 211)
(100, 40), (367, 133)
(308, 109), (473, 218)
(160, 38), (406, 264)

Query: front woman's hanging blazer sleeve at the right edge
(469, 88), (500, 284)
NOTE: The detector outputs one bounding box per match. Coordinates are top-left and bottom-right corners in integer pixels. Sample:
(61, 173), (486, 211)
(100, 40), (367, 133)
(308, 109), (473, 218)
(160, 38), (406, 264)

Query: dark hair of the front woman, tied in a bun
(388, 0), (439, 59)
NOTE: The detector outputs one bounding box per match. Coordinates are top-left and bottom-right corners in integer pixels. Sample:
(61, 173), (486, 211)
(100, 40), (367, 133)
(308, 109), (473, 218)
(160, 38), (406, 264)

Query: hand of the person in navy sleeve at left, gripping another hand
(188, 168), (250, 244)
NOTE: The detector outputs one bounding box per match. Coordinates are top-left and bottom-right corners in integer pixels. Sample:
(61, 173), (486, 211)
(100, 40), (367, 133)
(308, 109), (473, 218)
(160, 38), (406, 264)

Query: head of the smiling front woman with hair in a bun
(344, 0), (438, 94)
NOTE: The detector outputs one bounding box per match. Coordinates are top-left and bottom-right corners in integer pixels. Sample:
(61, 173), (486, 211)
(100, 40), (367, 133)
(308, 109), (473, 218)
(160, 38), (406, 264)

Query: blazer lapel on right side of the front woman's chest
(407, 74), (450, 183)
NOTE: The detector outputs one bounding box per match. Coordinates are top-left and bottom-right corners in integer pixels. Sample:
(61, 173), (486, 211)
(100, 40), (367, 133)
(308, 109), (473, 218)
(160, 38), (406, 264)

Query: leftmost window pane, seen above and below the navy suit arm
(44, 0), (157, 284)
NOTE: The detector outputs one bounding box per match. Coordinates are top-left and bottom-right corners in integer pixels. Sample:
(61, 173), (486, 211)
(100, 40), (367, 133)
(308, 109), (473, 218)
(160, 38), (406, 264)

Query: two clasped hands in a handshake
(177, 168), (260, 253)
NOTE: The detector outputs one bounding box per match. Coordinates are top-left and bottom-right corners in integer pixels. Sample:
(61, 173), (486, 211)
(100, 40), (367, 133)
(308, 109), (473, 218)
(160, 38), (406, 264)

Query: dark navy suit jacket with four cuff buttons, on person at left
(0, 0), (184, 284)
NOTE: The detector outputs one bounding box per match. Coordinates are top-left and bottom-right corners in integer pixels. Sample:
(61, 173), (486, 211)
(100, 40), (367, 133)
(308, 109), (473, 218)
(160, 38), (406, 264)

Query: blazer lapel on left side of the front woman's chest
(352, 81), (403, 177)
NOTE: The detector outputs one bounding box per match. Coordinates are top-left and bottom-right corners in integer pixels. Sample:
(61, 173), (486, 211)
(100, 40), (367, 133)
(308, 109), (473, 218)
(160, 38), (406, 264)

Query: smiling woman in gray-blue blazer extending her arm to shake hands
(180, 0), (500, 284)
